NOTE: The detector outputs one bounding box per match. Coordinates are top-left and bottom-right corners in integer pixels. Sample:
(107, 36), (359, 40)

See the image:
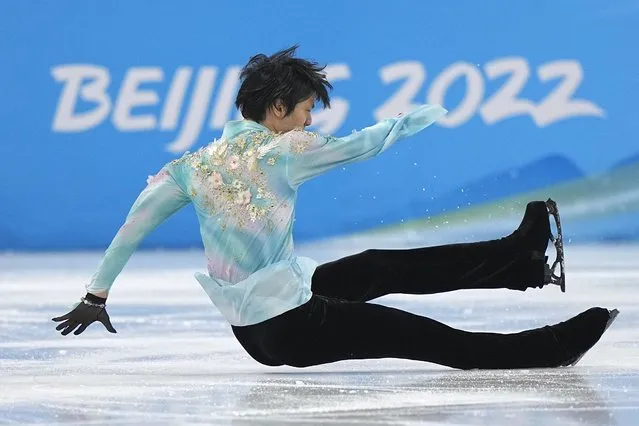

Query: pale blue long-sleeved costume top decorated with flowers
(87, 105), (446, 326)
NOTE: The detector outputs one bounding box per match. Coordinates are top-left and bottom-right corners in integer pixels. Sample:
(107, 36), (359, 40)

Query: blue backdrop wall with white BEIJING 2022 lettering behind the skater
(0, 0), (639, 250)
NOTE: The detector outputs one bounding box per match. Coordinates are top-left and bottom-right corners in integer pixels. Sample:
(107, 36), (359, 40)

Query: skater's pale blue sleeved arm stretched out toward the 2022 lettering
(282, 105), (447, 186)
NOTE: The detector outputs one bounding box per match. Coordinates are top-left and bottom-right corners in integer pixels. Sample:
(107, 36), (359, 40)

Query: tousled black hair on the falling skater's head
(235, 45), (333, 122)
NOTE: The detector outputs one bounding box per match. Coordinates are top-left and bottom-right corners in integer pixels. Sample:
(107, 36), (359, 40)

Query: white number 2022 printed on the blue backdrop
(374, 57), (605, 127)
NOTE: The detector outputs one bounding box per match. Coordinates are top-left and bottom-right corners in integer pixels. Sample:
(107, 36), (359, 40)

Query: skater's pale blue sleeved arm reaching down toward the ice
(87, 164), (191, 297)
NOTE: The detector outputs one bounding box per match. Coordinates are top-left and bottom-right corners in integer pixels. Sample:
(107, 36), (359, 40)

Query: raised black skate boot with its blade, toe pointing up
(510, 198), (566, 292)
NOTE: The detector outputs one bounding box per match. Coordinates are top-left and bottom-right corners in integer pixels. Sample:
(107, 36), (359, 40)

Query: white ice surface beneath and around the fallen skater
(0, 240), (639, 425)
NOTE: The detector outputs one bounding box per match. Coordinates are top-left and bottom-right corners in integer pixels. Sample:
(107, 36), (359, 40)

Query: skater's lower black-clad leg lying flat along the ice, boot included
(234, 296), (609, 369)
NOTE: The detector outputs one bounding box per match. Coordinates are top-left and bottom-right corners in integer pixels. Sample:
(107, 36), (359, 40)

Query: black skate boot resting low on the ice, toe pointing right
(546, 308), (619, 367)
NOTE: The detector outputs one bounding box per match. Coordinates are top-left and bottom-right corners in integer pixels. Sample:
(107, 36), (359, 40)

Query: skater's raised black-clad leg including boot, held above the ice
(312, 201), (564, 301)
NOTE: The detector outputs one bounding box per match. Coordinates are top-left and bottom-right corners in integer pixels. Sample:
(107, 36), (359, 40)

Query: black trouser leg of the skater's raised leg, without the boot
(312, 243), (545, 301)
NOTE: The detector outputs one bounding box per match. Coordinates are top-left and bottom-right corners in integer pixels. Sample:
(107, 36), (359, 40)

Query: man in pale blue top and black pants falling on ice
(54, 47), (617, 369)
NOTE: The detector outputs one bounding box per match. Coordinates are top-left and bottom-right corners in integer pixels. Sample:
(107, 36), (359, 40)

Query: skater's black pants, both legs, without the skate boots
(233, 237), (560, 369)
